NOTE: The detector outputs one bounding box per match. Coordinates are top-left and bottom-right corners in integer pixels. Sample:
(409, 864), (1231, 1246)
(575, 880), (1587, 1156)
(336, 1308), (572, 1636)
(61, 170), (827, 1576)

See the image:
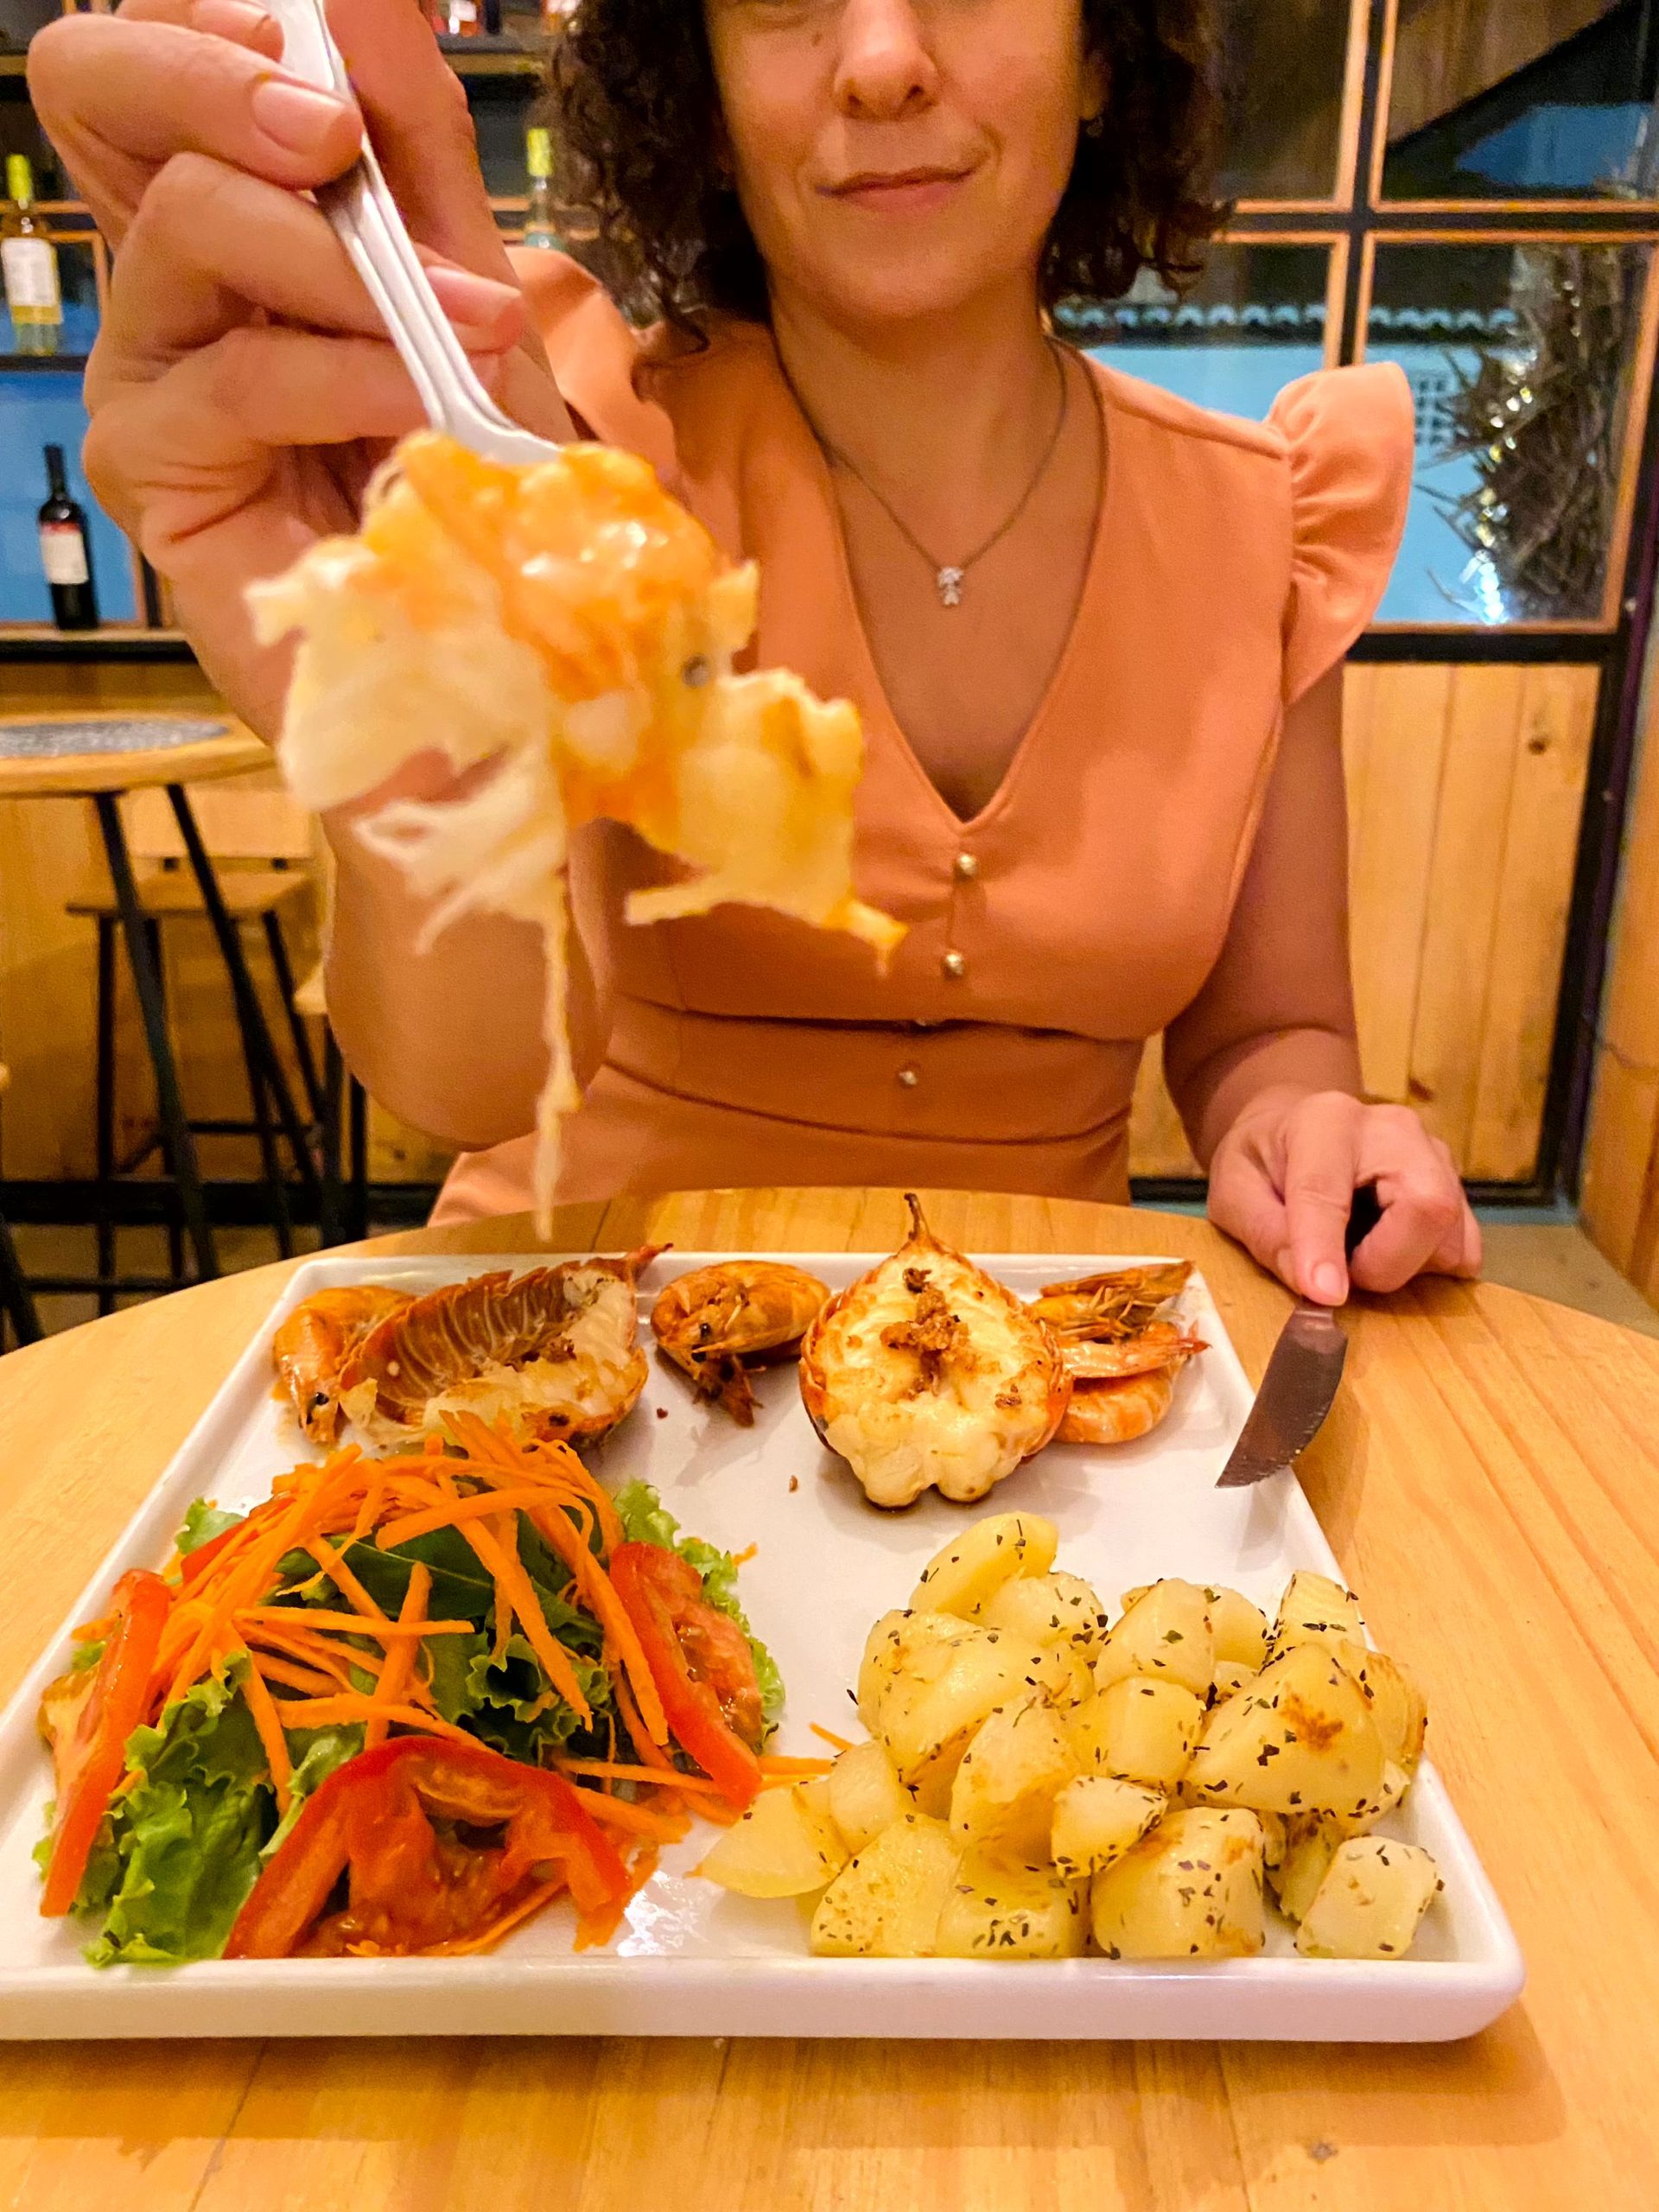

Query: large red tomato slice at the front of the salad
(224, 1737), (628, 1958)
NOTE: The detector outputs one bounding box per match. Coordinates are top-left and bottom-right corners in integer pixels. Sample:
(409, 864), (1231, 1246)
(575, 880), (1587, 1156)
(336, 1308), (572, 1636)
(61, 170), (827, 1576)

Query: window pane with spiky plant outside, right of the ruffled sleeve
(1370, 245), (1650, 626)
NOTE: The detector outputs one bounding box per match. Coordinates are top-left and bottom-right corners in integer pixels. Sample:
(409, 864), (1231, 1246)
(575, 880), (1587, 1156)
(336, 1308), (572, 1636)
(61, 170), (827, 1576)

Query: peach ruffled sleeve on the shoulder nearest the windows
(1268, 363), (1415, 706)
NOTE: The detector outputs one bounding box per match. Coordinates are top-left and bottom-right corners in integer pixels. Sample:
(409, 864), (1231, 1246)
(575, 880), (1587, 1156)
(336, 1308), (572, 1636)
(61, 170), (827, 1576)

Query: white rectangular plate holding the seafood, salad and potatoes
(0, 1252), (1524, 2042)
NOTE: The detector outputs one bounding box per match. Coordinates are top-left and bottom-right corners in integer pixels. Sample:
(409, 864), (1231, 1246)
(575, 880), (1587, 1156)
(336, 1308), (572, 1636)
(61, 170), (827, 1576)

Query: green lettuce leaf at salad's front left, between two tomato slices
(75, 1662), (276, 1967)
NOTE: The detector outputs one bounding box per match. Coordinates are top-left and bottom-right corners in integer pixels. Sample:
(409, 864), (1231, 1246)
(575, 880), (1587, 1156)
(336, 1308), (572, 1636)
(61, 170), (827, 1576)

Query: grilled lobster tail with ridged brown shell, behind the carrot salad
(339, 1245), (664, 1445)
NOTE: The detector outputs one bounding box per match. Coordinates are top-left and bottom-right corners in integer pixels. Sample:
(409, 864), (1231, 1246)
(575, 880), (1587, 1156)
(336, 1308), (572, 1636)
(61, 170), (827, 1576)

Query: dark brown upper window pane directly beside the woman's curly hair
(1224, 0), (1350, 199)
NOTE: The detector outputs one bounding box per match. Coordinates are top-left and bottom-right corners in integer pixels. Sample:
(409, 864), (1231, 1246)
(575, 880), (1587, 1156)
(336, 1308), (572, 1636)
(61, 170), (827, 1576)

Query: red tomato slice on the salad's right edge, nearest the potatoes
(611, 1544), (766, 1809)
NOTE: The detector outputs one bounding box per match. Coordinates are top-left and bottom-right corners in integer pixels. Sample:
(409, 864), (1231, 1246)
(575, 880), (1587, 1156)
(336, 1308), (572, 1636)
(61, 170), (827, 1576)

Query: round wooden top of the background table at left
(0, 712), (270, 798)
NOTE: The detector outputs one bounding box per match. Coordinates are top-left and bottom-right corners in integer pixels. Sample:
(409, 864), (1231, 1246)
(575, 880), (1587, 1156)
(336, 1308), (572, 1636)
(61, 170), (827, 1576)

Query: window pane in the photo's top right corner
(1382, 0), (1659, 199)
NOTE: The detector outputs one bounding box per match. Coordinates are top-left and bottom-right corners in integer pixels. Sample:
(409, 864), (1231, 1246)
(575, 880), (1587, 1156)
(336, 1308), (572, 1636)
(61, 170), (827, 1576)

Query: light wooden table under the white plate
(0, 1190), (1659, 2212)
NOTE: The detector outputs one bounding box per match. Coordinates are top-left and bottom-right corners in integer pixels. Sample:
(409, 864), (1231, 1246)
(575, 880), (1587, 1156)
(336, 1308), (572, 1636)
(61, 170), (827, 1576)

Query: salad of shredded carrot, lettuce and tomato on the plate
(35, 1414), (791, 1964)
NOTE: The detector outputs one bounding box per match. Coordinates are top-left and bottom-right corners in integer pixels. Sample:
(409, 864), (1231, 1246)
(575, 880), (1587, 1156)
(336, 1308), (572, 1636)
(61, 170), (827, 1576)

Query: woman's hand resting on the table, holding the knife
(1210, 1090), (1480, 1305)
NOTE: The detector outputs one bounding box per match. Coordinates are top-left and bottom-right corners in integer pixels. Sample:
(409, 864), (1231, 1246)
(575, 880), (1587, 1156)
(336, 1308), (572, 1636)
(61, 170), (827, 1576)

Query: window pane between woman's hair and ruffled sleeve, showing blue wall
(1059, 245), (1330, 420)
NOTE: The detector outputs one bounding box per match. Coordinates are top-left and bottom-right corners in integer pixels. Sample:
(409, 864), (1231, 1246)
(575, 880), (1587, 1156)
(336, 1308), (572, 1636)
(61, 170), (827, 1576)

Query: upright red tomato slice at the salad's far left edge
(40, 1568), (173, 1920)
